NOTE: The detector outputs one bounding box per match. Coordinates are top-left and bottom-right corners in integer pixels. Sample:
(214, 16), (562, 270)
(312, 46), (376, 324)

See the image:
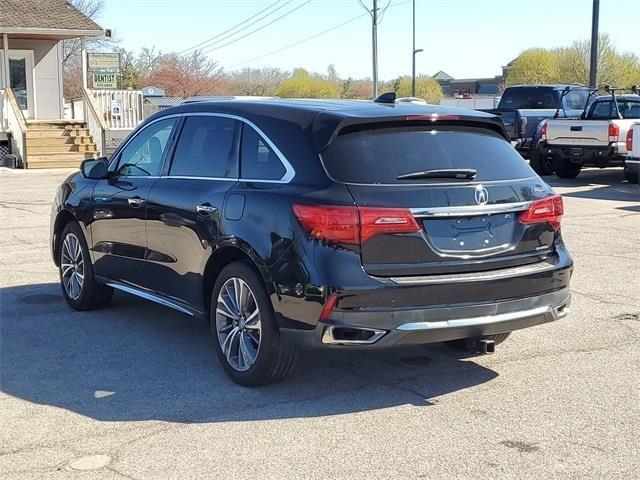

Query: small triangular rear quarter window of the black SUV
(240, 125), (286, 180)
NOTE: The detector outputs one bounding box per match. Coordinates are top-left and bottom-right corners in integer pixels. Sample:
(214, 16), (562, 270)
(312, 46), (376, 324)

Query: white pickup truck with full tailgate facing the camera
(537, 95), (640, 178)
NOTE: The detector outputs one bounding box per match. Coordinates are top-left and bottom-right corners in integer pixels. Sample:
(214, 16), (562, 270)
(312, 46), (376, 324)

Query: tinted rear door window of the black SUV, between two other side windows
(169, 116), (240, 178)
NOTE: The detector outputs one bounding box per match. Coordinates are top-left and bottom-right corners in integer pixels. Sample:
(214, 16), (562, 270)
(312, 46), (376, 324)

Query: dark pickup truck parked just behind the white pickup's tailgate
(483, 85), (589, 158)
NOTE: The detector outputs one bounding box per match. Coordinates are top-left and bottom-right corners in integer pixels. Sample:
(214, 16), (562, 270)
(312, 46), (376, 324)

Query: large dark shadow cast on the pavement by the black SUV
(0, 284), (497, 423)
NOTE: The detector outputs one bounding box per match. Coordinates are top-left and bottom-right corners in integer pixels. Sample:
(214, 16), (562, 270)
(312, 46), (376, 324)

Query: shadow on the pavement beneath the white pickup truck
(543, 168), (640, 202)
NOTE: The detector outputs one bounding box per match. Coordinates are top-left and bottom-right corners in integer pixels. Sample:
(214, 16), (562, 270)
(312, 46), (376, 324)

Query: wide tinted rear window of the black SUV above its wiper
(322, 127), (535, 185)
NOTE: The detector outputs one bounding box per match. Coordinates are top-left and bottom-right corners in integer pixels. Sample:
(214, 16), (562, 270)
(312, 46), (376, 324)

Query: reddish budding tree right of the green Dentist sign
(146, 51), (223, 98)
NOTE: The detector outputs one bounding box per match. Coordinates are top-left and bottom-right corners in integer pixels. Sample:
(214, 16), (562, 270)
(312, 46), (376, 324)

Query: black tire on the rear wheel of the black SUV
(209, 262), (299, 387)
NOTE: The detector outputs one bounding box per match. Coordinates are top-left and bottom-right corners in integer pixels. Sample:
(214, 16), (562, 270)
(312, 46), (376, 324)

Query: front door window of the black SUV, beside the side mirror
(118, 118), (176, 177)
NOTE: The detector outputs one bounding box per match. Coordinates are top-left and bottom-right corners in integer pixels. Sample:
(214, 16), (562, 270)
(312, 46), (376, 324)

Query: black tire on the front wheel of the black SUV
(58, 222), (113, 310)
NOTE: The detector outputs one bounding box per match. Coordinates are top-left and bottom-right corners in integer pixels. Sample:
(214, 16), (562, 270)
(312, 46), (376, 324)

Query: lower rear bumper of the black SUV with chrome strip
(281, 287), (571, 348)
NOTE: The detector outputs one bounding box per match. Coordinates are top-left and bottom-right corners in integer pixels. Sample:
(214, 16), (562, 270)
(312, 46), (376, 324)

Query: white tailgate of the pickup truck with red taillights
(547, 120), (609, 147)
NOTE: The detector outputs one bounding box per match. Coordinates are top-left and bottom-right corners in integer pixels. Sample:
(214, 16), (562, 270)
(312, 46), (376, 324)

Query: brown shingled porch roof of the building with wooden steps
(0, 0), (104, 38)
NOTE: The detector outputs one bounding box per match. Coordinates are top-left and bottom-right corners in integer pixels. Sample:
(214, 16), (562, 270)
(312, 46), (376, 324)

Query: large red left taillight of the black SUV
(293, 205), (421, 245)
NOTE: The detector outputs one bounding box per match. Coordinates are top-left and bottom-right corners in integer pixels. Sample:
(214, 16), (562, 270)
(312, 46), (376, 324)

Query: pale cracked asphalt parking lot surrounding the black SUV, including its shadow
(0, 169), (640, 480)
